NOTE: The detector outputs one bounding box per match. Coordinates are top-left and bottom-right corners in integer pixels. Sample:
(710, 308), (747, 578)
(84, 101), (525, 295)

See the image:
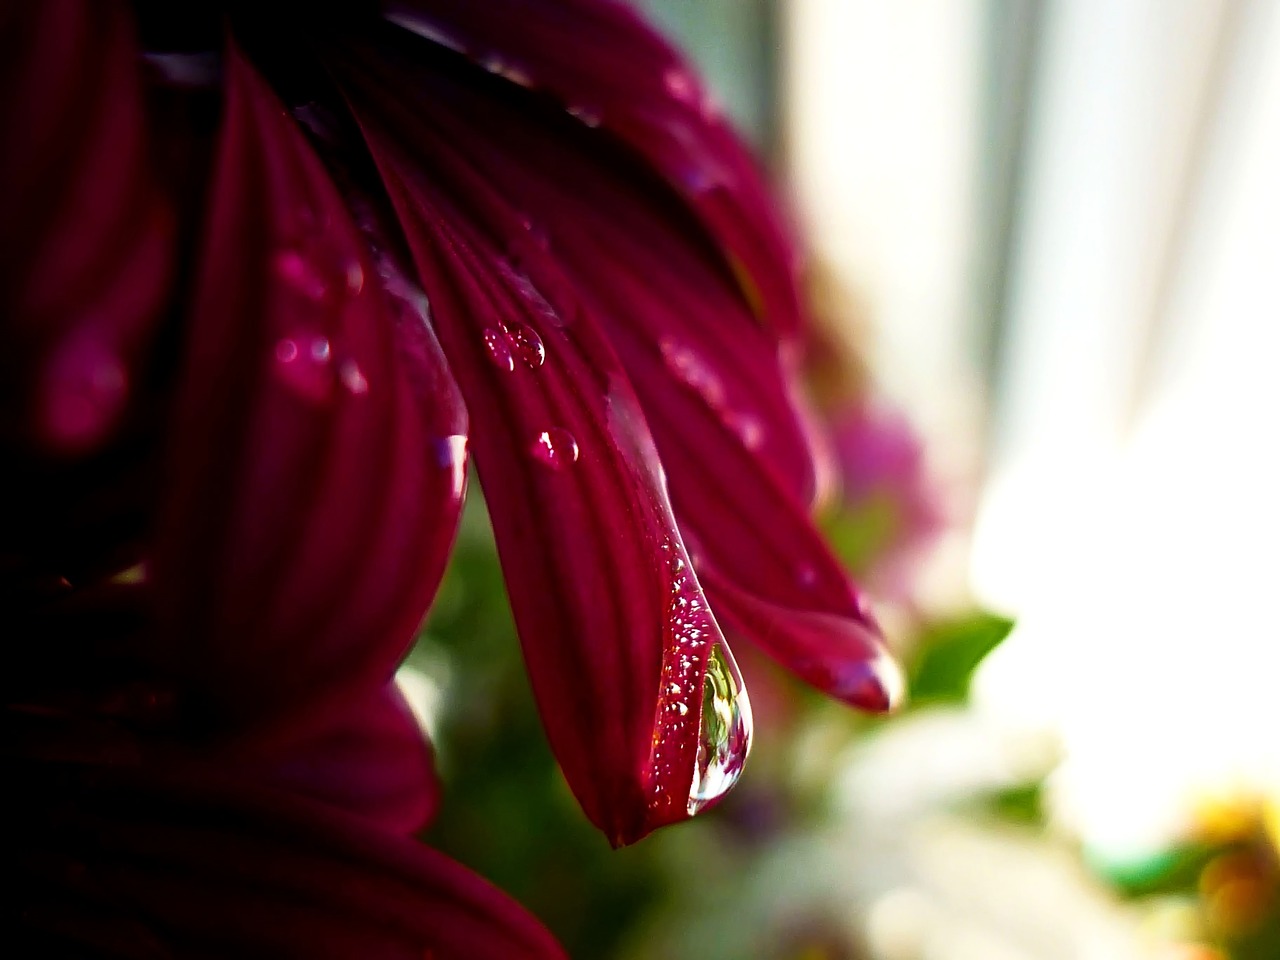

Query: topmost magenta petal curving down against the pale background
(384, 0), (801, 337)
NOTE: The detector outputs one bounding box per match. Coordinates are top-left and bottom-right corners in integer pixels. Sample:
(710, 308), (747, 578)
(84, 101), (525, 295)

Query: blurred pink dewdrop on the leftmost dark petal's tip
(41, 337), (128, 449)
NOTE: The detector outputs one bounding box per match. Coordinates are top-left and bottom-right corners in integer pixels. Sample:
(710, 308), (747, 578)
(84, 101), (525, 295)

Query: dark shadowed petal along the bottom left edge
(19, 771), (563, 960)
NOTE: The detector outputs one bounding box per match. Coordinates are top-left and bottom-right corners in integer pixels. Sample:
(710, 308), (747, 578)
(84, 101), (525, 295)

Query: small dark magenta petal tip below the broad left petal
(230, 684), (440, 835)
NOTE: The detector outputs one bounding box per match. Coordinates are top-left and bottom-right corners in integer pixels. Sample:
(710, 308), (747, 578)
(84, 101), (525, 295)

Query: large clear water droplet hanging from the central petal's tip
(689, 643), (751, 817)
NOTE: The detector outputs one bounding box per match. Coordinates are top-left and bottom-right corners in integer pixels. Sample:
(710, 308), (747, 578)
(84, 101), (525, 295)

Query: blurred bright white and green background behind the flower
(401, 0), (1280, 960)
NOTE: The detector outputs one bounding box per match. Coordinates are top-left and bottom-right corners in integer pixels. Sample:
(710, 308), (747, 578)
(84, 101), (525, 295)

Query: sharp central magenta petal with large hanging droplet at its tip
(337, 51), (745, 844)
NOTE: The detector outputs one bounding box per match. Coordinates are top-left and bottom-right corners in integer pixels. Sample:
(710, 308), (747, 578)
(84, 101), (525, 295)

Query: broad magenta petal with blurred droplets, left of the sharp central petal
(148, 46), (466, 742)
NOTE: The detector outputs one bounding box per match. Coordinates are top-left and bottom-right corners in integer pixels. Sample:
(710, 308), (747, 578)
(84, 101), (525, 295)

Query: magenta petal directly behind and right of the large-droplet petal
(325, 28), (901, 710)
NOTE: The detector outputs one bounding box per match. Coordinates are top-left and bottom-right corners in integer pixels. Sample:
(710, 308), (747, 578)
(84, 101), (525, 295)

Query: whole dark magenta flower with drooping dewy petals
(0, 0), (900, 956)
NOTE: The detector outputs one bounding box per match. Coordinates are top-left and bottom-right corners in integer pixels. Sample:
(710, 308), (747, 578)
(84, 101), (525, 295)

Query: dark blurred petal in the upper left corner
(0, 0), (174, 453)
